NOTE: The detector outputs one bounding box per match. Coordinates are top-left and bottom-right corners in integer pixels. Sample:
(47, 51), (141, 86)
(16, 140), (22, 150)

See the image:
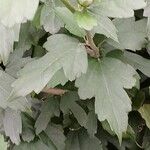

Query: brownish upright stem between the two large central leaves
(86, 30), (100, 58)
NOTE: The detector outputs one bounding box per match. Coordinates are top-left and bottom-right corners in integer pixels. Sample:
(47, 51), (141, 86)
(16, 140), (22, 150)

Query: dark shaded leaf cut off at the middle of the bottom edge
(66, 130), (102, 150)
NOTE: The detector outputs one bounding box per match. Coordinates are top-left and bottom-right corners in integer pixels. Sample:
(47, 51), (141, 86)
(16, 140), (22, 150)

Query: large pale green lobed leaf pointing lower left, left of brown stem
(12, 34), (88, 96)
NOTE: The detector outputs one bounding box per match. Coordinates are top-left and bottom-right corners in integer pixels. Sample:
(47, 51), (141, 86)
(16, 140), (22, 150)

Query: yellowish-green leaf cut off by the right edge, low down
(138, 104), (150, 129)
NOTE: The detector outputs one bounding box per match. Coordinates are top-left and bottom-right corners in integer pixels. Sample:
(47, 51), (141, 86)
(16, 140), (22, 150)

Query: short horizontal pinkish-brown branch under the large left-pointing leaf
(42, 87), (68, 95)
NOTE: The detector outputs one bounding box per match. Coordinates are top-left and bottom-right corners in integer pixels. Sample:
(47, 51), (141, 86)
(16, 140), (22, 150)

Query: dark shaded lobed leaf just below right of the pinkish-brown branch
(60, 92), (87, 126)
